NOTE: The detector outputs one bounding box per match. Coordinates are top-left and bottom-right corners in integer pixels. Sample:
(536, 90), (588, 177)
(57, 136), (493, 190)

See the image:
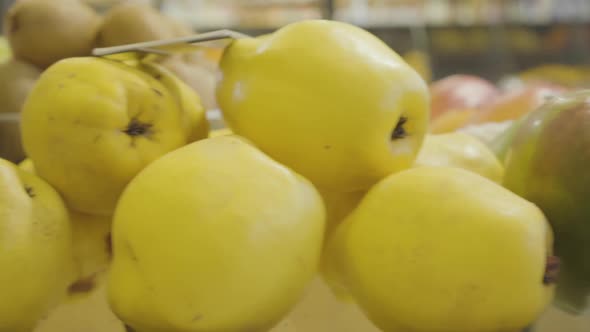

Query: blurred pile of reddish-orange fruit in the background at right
(430, 63), (590, 133)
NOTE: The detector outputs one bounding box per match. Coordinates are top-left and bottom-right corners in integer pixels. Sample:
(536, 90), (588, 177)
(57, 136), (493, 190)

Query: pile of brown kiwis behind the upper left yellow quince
(0, 0), (219, 161)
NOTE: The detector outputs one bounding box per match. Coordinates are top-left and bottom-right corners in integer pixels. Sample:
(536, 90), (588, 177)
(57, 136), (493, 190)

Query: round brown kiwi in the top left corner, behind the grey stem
(3, 0), (101, 68)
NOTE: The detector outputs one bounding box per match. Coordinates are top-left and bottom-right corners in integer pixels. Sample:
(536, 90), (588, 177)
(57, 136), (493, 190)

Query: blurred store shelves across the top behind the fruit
(0, 0), (590, 81)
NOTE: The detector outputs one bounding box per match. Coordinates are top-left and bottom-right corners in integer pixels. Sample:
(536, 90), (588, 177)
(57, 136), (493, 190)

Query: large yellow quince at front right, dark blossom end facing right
(329, 167), (554, 332)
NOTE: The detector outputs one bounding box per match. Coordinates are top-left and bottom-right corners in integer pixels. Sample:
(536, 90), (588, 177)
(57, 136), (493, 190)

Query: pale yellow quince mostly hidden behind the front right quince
(414, 132), (504, 183)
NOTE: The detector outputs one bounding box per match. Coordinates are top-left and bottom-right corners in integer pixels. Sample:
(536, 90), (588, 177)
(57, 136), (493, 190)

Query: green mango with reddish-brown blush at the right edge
(502, 90), (590, 314)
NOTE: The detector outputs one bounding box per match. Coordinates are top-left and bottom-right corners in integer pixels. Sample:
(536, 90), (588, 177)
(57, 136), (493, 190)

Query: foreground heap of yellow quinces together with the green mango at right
(0, 4), (590, 332)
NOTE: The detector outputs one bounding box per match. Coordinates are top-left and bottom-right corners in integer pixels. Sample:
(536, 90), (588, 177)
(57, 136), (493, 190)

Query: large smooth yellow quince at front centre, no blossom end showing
(108, 136), (325, 332)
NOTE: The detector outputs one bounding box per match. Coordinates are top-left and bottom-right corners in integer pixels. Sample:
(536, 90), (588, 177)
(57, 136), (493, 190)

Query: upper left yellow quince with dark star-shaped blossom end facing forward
(22, 58), (206, 215)
